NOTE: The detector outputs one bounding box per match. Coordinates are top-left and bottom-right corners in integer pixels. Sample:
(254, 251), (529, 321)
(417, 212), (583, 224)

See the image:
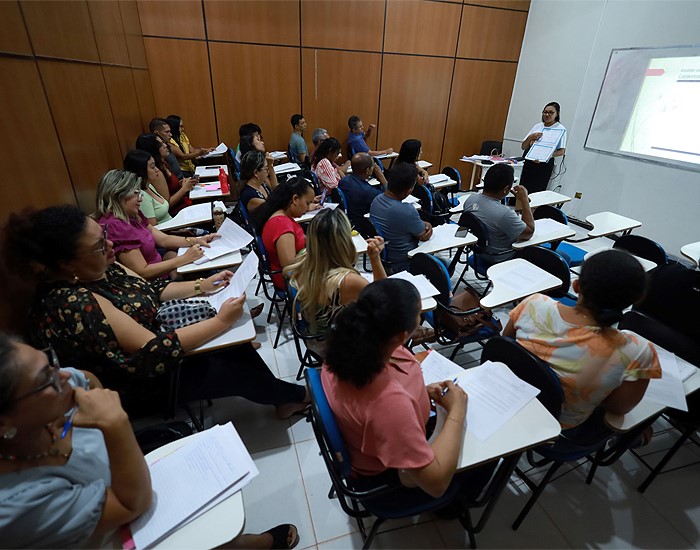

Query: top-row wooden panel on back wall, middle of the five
(301, 0), (384, 52)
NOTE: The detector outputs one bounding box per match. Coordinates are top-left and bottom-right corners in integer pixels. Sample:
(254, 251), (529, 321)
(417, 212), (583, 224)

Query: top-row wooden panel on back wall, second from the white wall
(384, 0), (462, 57)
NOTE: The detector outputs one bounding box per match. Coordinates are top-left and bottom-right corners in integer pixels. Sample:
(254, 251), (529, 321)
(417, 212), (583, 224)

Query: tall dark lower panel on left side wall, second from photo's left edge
(39, 61), (122, 212)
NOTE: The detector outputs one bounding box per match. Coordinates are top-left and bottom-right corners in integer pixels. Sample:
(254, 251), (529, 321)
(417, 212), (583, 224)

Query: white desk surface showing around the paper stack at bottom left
(145, 437), (245, 550)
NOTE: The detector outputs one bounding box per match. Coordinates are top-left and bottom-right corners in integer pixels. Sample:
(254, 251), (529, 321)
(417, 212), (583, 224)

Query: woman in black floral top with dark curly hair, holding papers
(6, 206), (306, 417)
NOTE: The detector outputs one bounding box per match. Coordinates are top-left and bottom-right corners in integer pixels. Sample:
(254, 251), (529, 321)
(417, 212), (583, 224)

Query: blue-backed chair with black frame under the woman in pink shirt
(305, 369), (476, 548)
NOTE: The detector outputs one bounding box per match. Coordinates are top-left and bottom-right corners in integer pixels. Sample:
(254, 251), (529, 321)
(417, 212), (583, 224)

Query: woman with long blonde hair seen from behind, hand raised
(288, 208), (386, 357)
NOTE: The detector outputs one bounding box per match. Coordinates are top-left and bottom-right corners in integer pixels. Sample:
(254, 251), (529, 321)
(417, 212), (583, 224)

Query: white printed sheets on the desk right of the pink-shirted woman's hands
(458, 361), (540, 441)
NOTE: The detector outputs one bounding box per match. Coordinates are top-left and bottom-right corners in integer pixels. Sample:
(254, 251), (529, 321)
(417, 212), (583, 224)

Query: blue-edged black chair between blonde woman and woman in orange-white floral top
(408, 253), (500, 359)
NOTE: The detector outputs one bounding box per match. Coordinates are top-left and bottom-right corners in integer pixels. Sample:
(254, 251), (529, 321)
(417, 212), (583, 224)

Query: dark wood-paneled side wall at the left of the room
(0, 0), (155, 220)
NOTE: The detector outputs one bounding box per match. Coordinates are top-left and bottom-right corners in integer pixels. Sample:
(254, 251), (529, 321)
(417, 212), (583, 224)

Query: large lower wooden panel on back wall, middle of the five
(298, 49), (382, 154)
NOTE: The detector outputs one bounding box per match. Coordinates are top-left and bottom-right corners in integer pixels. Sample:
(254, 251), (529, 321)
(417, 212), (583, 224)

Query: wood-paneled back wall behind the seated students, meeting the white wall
(138, 0), (530, 182)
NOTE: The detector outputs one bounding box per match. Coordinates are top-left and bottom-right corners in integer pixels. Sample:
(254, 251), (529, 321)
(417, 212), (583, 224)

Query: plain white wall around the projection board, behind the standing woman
(504, 0), (700, 255)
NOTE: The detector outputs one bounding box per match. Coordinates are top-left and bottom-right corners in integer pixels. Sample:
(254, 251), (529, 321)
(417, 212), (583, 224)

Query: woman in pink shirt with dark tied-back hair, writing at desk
(321, 279), (497, 505)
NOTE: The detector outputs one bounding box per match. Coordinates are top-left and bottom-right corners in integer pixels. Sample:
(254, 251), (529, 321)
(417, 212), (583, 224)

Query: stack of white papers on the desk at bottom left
(131, 422), (258, 549)
